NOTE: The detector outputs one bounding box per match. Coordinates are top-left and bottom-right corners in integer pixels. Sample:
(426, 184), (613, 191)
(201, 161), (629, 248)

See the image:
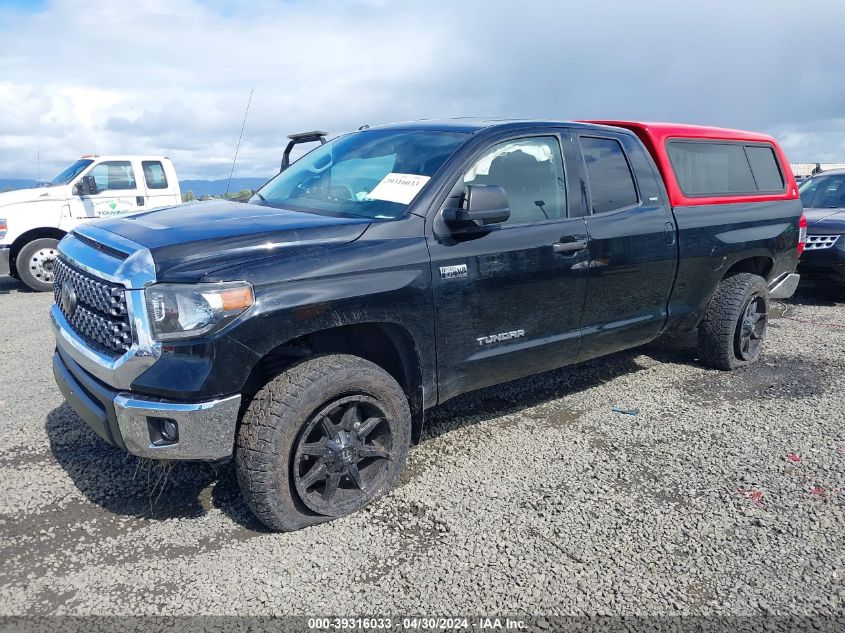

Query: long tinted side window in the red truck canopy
(666, 140), (784, 196)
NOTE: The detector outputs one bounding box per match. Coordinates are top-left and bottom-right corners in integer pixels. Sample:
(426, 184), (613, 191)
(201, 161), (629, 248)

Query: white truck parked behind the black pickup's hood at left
(0, 155), (182, 291)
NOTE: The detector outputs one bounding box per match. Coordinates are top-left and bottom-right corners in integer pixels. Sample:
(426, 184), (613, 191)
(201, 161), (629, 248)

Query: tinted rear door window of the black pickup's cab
(580, 136), (639, 213)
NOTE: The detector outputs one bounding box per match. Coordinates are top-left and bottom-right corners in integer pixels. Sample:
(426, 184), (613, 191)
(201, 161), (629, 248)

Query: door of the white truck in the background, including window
(70, 160), (145, 219)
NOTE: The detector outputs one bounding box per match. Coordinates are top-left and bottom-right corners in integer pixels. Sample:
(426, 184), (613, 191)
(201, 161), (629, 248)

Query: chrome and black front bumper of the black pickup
(53, 349), (241, 461)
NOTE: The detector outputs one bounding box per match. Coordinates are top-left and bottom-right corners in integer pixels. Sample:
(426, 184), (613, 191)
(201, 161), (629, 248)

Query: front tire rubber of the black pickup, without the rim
(235, 354), (411, 532)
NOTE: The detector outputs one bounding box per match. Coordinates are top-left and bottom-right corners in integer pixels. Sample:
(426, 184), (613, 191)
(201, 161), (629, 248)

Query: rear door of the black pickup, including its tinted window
(578, 131), (678, 360)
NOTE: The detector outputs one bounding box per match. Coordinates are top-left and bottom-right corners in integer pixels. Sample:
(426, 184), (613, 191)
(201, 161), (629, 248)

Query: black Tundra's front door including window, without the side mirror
(429, 131), (588, 402)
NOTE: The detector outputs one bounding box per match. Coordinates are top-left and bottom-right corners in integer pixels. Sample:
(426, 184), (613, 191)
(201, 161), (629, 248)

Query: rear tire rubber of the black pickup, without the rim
(698, 273), (769, 370)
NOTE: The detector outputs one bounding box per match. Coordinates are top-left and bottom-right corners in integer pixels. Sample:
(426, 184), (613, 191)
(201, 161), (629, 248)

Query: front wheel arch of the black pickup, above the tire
(243, 321), (424, 442)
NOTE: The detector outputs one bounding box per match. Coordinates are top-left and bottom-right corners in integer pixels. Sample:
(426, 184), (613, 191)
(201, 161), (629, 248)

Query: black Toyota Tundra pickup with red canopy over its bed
(51, 120), (805, 530)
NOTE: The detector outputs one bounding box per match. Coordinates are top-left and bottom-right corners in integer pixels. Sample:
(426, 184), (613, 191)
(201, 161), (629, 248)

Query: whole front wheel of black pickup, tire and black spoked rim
(235, 354), (411, 531)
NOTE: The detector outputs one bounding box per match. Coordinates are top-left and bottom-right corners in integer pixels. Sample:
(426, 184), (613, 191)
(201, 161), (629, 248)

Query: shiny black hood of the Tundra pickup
(90, 200), (371, 280)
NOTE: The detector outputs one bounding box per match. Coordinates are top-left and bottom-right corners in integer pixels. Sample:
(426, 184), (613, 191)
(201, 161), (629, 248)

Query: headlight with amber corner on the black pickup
(144, 281), (255, 341)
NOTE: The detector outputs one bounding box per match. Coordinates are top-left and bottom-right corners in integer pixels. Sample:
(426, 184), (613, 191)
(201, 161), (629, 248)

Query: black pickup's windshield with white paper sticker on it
(249, 130), (468, 219)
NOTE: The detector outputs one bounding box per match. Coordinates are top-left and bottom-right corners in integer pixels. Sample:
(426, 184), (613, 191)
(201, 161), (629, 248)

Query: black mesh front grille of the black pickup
(53, 258), (132, 357)
